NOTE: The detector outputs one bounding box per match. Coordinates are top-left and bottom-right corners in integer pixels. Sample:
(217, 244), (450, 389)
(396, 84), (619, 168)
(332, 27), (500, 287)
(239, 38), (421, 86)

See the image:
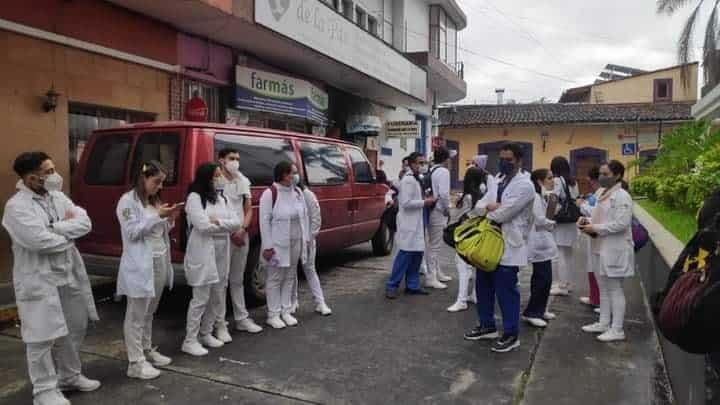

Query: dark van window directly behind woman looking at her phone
(130, 132), (180, 185)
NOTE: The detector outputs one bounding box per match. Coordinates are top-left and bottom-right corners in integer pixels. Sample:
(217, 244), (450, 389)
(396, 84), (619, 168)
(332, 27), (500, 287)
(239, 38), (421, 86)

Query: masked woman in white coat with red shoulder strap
(260, 161), (311, 329)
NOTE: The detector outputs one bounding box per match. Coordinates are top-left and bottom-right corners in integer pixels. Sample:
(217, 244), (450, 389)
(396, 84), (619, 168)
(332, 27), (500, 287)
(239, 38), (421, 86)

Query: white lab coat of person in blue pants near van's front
(395, 175), (425, 252)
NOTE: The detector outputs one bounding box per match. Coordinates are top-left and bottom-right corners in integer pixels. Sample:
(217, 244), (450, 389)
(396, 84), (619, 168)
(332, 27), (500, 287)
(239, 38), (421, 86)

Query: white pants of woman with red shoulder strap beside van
(265, 239), (303, 318)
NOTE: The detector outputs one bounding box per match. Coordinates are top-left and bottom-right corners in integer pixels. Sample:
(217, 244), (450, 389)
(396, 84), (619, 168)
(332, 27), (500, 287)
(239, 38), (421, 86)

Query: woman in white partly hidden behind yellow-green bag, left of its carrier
(447, 166), (497, 312)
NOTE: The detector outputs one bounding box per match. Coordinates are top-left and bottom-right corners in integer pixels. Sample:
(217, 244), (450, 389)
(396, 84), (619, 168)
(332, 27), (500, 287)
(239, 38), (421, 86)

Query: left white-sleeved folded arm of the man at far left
(2, 204), (72, 254)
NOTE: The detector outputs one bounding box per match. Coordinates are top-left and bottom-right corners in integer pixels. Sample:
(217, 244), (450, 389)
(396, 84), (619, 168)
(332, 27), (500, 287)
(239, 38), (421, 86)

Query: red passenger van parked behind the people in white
(72, 122), (394, 300)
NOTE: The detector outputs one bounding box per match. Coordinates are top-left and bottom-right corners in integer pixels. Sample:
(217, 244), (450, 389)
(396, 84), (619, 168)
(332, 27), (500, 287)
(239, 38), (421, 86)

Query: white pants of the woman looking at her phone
(123, 255), (172, 363)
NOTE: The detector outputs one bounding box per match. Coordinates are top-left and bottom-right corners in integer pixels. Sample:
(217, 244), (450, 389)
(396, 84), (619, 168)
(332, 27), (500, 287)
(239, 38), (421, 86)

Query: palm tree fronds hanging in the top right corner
(657, 0), (720, 86)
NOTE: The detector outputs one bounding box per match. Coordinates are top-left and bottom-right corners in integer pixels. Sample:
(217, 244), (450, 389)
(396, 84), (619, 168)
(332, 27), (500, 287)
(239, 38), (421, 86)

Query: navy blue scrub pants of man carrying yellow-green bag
(475, 266), (520, 336)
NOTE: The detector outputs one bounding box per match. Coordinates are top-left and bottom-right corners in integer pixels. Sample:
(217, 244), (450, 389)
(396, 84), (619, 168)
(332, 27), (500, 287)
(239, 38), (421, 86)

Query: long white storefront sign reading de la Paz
(255, 0), (427, 100)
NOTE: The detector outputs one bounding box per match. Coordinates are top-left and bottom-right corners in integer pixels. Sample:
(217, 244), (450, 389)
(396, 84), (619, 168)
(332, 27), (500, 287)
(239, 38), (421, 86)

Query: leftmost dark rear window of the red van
(85, 134), (132, 186)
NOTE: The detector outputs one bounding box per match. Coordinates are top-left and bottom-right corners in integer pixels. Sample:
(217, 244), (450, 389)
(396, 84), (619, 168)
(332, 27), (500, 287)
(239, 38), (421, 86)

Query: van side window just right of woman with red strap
(300, 142), (348, 186)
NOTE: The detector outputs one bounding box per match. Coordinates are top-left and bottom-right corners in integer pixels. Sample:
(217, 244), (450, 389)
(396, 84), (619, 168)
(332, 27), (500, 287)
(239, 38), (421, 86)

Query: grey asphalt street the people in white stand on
(0, 241), (671, 405)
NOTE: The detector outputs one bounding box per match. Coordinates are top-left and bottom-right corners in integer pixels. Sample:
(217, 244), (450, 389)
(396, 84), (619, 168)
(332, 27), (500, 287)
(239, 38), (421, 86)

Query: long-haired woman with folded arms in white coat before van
(182, 163), (242, 356)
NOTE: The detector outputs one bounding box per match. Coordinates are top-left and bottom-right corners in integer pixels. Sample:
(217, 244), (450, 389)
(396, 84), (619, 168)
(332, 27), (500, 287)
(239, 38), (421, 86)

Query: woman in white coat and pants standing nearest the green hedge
(578, 160), (635, 342)
